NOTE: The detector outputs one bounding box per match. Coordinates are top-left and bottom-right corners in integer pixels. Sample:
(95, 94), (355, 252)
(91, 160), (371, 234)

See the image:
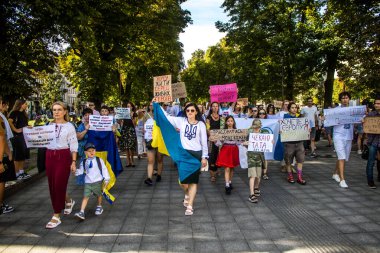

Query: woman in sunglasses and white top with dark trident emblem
(160, 103), (208, 215)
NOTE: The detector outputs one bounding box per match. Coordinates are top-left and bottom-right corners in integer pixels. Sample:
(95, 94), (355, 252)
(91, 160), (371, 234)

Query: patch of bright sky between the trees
(179, 0), (228, 63)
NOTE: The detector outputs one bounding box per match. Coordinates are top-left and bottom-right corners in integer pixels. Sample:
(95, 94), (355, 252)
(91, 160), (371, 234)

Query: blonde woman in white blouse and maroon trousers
(45, 102), (78, 228)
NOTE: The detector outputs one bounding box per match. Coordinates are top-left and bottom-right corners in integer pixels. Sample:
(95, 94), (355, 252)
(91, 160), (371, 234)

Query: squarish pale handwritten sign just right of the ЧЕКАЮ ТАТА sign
(280, 118), (310, 142)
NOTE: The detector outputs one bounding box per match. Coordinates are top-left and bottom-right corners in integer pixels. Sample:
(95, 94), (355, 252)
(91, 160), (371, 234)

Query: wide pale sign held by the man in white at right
(323, 105), (367, 127)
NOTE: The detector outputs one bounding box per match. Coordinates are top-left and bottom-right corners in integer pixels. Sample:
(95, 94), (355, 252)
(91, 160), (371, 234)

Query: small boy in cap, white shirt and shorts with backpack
(75, 143), (110, 220)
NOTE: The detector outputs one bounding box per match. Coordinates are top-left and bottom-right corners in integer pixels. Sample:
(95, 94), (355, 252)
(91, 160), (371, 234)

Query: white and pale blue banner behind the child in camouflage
(235, 118), (280, 160)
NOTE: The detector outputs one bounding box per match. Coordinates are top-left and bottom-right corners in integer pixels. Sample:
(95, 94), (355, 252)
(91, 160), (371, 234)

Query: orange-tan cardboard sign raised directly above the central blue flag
(153, 75), (173, 102)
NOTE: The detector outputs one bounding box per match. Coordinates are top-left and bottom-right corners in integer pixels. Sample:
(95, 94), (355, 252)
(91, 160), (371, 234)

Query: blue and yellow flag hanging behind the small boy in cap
(87, 130), (123, 204)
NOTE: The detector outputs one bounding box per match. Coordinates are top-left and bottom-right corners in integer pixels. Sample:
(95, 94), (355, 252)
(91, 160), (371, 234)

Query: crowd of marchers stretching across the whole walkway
(0, 92), (380, 229)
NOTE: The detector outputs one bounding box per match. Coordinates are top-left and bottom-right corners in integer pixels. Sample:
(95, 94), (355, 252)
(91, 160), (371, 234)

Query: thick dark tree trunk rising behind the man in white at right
(323, 51), (338, 108)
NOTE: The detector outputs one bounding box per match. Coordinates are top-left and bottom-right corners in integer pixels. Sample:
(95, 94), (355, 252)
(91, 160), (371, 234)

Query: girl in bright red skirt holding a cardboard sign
(216, 116), (240, 194)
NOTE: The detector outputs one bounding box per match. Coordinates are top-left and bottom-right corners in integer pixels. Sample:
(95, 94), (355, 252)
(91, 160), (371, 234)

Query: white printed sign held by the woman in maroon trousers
(22, 124), (56, 149)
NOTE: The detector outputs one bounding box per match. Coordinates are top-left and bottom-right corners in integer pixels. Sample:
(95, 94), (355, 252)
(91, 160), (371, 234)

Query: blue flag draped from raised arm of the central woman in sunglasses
(153, 103), (201, 182)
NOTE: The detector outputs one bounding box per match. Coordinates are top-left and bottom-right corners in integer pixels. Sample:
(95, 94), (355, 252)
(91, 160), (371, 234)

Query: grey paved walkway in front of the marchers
(0, 142), (380, 253)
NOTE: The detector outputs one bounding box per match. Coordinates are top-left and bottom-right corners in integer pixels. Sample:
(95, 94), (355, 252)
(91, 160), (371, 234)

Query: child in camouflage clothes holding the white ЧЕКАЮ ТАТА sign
(247, 119), (265, 203)
